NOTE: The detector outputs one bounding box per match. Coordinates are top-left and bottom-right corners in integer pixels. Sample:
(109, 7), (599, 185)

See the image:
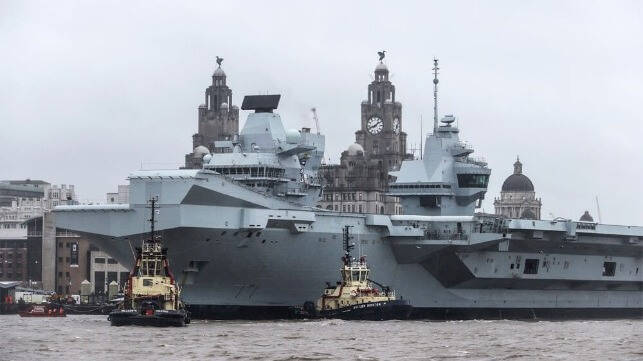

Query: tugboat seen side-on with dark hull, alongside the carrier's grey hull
(304, 226), (413, 321)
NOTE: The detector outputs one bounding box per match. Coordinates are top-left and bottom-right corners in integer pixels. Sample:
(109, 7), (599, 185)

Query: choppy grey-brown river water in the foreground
(0, 315), (643, 361)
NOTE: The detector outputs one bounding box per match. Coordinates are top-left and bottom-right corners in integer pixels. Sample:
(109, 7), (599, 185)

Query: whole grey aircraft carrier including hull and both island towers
(55, 61), (643, 319)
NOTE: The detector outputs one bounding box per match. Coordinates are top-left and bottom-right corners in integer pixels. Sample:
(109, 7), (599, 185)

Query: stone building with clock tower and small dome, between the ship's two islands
(318, 61), (408, 214)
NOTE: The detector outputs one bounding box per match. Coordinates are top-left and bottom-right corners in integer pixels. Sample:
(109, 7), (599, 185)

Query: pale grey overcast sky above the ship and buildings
(0, 0), (643, 226)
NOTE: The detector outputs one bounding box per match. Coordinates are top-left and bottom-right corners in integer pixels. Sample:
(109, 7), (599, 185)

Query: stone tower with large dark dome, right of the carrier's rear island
(493, 158), (542, 219)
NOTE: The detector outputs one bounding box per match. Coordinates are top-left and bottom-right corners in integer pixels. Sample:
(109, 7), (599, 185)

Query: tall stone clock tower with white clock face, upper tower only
(355, 55), (406, 170)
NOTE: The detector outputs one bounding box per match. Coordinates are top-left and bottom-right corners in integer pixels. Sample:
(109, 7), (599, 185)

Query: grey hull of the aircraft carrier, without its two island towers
(56, 175), (643, 319)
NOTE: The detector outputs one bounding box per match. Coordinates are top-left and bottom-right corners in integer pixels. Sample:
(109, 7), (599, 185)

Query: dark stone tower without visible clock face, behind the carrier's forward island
(185, 61), (239, 168)
